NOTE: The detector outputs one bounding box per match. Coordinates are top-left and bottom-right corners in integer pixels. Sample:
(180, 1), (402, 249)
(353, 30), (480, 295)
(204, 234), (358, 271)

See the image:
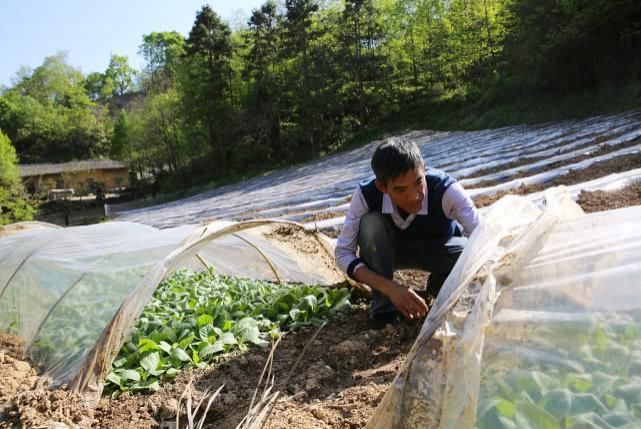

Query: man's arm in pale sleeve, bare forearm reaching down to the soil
(334, 187), (427, 319)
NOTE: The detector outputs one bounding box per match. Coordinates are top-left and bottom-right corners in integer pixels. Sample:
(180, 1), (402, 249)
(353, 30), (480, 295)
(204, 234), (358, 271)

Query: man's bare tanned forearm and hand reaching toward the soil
(354, 267), (427, 319)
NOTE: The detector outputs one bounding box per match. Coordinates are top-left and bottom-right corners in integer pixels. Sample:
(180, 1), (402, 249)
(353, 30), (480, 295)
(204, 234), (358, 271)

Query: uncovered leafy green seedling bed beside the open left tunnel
(105, 271), (350, 396)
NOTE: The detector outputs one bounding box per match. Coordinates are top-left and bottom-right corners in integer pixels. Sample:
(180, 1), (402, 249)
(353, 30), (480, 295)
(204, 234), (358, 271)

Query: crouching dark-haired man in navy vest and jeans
(335, 138), (479, 329)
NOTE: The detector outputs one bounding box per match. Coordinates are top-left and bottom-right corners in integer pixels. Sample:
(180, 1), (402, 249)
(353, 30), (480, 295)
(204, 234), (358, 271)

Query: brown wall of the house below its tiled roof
(24, 168), (129, 194)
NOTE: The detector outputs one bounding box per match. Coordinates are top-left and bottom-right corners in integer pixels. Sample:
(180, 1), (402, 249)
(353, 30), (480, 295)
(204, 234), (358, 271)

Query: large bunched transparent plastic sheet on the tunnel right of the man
(368, 188), (641, 429)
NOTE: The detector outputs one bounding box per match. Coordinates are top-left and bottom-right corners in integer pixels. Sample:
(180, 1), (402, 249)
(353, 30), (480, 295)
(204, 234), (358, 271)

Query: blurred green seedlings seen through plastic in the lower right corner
(477, 314), (641, 429)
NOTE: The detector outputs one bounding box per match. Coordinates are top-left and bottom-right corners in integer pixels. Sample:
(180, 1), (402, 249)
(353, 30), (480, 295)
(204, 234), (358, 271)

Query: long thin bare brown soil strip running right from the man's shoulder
(474, 153), (641, 207)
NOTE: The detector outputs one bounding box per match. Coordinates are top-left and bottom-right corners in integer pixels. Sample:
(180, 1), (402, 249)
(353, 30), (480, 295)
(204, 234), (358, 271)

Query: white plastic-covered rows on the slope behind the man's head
(112, 110), (641, 228)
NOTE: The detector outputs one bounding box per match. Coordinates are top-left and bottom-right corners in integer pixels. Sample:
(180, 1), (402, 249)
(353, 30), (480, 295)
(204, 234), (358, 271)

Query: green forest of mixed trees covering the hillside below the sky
(0, 0), (641, 189)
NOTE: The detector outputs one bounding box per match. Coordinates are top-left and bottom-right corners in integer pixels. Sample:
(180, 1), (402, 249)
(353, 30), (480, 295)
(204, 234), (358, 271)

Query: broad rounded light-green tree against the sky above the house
(0, 53), (111, 162)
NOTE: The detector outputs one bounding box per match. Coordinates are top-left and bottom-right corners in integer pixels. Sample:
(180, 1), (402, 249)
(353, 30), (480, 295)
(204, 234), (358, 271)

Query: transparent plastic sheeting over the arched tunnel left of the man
(0, 221), (343, 392)
